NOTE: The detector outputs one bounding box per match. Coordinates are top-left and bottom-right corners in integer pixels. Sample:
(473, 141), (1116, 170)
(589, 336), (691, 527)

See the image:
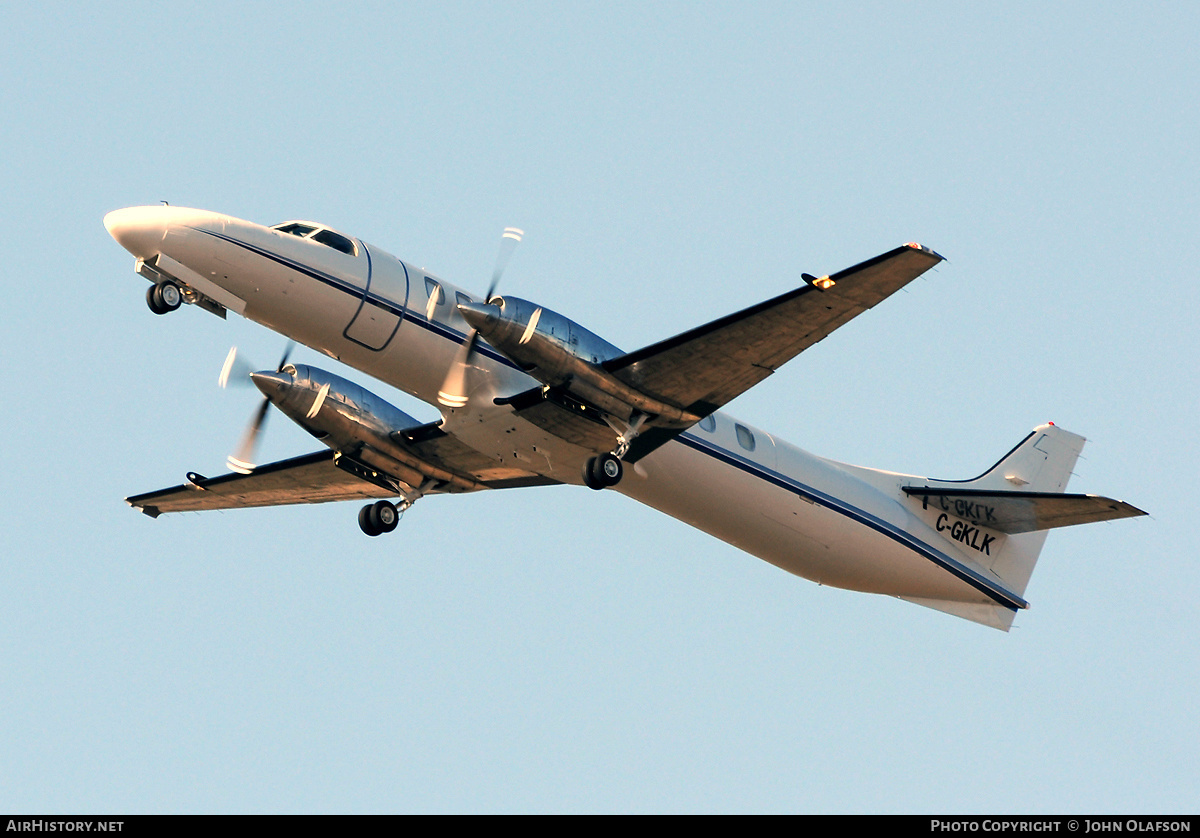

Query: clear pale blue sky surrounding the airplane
(0, 2), (1200, 813)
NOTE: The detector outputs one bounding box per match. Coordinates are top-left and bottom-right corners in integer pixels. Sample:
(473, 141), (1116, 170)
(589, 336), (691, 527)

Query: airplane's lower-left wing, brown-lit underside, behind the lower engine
(125, 424), (558, 517)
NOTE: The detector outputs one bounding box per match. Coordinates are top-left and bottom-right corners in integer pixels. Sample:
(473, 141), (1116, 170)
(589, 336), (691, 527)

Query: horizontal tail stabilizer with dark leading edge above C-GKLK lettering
(902, 486), (1146, 535)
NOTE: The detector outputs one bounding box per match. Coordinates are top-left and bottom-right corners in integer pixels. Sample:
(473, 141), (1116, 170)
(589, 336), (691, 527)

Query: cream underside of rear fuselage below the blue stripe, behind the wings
(618, 434), (990, 601)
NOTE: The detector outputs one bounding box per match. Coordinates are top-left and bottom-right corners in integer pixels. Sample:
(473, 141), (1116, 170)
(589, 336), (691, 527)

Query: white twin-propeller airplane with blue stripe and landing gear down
(104, 205), (1146, 632)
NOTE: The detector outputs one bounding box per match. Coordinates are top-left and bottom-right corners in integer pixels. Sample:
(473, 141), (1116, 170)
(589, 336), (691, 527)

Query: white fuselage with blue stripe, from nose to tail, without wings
(106, 206), (1024, 606)
